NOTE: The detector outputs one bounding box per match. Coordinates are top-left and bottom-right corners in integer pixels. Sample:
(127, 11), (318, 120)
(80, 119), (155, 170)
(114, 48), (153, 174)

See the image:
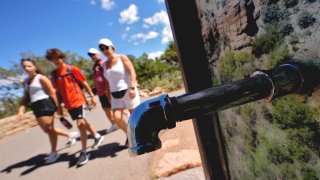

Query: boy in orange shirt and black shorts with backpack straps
(46, 48), (104, 165)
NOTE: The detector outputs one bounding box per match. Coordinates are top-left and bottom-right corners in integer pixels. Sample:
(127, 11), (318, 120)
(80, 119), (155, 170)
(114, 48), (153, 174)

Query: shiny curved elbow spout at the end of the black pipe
(127, 94), (176, 156)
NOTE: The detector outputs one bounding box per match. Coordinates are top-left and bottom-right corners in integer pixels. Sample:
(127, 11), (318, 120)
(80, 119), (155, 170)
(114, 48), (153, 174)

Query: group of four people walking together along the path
(17, 38), (140, 165)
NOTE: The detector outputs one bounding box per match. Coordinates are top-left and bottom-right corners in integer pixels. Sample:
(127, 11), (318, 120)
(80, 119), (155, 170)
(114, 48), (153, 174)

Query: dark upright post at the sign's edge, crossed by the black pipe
(166, 0), (230, 179)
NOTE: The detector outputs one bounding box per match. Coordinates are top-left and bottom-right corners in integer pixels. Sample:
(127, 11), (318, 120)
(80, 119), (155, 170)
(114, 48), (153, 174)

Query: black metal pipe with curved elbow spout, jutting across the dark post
(127, 63), (319, 156)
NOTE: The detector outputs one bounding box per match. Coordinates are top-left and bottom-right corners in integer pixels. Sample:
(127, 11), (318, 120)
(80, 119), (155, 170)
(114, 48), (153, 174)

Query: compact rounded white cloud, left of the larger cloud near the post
(119, 4), (139, 24)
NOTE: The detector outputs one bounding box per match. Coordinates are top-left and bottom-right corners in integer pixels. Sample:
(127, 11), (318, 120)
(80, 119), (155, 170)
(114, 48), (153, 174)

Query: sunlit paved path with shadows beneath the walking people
(0, 89), (202, 180)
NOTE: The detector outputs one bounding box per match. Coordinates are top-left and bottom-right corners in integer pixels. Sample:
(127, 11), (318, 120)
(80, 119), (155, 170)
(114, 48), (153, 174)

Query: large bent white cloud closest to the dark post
(143, 11), (173, 44)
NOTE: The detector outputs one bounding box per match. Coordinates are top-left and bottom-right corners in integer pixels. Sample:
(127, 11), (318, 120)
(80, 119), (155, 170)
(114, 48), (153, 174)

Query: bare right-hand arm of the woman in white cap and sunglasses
(120, 55), (137, 99)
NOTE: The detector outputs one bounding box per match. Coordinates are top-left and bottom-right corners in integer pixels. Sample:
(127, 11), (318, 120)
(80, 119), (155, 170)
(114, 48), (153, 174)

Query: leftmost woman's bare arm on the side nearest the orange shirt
(40, 75), (62, 115)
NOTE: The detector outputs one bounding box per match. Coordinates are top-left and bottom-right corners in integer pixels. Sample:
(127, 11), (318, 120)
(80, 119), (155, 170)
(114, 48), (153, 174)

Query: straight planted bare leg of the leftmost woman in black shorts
(38, 116), (58, 152)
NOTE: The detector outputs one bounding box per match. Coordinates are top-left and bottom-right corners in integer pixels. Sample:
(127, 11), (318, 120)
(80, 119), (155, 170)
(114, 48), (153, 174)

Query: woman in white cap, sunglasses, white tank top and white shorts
(99, 38), (140, 143)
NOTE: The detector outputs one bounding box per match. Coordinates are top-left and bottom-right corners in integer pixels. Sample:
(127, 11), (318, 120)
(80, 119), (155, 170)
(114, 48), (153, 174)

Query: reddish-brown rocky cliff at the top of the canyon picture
(197, 0), (269, 67)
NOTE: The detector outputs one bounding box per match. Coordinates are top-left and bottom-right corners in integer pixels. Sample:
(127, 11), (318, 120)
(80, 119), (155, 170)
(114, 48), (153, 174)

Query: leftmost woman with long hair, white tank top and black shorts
(17, 59), (78, 163)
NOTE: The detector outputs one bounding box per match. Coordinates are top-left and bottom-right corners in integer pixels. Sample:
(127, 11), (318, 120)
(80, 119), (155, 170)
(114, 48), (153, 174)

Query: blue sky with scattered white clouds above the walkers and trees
(0, 0), (172, 68)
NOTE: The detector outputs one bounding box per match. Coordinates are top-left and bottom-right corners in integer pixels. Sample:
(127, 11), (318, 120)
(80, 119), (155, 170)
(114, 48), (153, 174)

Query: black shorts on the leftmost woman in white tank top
(31, 98), (57, 118)
